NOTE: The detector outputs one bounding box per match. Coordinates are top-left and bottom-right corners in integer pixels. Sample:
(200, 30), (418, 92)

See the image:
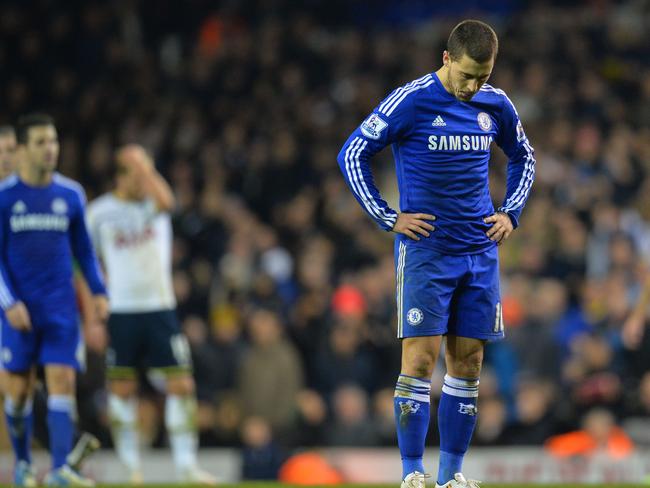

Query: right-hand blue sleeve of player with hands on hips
(496, 95), (535, 228)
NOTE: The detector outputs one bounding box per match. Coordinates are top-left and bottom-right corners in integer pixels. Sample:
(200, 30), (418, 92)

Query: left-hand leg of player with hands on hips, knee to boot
(394, 336), (442, 488)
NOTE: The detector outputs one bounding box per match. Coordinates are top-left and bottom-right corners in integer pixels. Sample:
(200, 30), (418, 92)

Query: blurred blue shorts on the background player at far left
(0, 315), (84, 373)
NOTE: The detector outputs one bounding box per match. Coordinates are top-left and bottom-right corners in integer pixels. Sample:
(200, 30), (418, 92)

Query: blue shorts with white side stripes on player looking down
(395, 239), (504, 340)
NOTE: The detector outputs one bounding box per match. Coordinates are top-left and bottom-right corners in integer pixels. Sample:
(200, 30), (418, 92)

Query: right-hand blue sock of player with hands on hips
(438, 375), (478, 485)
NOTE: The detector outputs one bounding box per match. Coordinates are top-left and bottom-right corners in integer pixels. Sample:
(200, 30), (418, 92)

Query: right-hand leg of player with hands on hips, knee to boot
(436, 334), (485, 488)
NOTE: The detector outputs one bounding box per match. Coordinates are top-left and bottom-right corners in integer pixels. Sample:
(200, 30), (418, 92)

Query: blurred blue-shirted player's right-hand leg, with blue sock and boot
(45, 364), (95, 487)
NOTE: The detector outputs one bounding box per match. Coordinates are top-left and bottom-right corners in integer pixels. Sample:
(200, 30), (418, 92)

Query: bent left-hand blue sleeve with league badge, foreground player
(337, 88), (414, 231)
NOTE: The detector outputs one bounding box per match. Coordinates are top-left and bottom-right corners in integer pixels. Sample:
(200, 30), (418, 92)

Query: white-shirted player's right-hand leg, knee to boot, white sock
(165, 373), (216, 485)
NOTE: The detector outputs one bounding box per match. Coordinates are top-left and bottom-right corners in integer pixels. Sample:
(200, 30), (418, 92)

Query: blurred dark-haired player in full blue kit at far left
(0, 114), (108, 486)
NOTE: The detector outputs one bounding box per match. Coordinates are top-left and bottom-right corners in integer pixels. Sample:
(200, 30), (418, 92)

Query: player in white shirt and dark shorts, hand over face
(88, 145), (215, 484)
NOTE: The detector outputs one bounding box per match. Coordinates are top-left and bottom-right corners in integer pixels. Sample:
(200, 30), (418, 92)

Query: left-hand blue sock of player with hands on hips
(394, 374), (431, 479)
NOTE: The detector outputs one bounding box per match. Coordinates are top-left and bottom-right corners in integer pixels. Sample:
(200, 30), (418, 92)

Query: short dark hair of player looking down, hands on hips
(447, 20), (499, 63)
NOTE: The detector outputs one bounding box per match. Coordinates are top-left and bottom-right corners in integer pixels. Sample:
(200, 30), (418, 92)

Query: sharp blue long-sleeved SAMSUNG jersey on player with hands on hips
(338, 73), (535, 255)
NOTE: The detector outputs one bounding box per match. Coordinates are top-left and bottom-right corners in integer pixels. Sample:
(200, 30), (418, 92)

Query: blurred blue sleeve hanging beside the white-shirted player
(70, 191), (106, 295)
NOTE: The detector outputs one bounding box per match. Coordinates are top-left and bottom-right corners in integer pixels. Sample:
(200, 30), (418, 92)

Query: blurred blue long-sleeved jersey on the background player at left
(0, 173), (106, 325)
